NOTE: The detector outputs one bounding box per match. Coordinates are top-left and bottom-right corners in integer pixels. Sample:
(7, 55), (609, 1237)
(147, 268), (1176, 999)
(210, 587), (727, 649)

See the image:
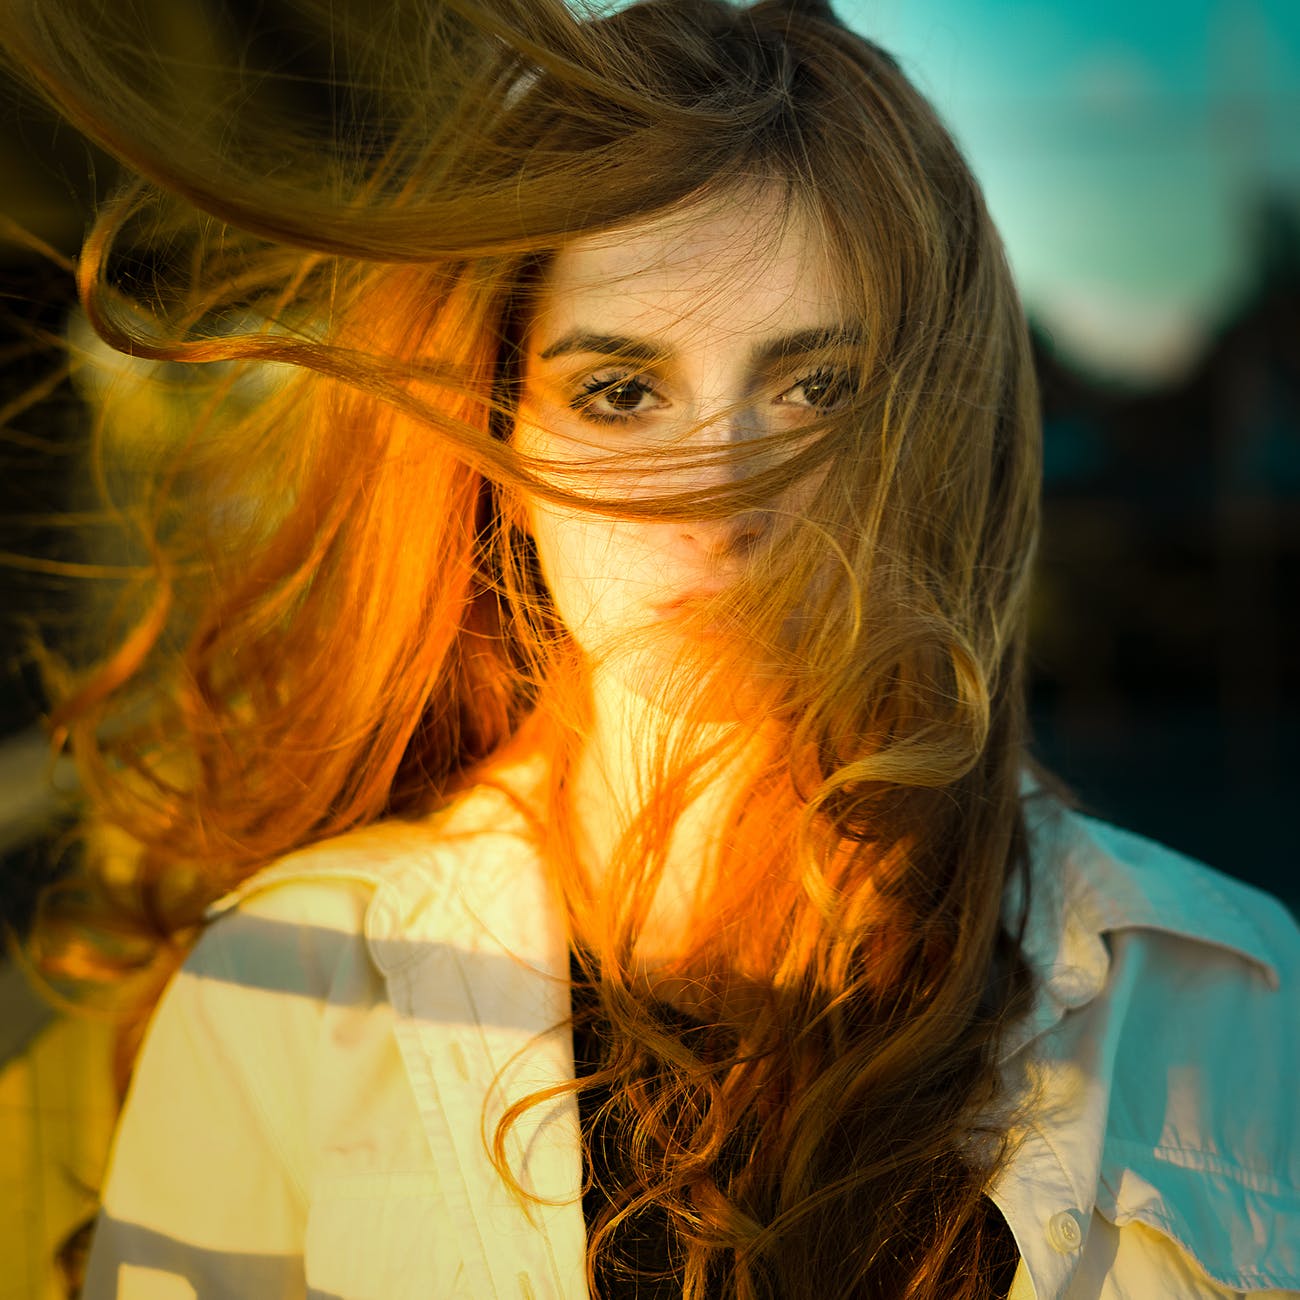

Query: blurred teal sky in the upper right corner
(836, 0), (1300, 378)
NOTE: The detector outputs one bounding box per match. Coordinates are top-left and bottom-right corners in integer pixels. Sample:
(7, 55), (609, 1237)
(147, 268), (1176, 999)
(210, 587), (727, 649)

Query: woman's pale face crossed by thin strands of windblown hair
(515, 189), (853, 689)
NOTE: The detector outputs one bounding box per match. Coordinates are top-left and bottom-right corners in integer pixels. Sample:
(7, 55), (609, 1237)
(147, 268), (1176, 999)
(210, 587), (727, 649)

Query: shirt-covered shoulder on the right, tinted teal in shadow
(1013, 807), (1300, 1295)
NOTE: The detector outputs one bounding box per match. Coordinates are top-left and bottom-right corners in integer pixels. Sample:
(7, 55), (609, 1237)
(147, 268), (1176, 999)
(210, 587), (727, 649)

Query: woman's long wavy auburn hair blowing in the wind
(0, 0), (1039, 1300)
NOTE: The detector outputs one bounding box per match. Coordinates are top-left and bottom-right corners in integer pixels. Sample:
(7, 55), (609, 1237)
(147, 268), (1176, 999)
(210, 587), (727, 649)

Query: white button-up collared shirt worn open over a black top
(85, 788), (1300, 1300)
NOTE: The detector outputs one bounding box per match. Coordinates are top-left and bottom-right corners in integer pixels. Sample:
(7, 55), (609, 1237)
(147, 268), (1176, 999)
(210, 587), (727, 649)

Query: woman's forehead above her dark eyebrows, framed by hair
(530, 187), (841, 346)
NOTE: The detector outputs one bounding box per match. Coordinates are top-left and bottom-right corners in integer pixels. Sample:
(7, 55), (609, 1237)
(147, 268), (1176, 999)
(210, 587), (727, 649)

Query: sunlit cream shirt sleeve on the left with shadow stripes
(83, 911), (338, 1300)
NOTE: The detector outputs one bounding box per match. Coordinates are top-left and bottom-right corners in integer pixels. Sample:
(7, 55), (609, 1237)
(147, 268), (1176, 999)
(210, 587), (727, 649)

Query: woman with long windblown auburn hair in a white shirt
(7, 0), (1300, 1297)
